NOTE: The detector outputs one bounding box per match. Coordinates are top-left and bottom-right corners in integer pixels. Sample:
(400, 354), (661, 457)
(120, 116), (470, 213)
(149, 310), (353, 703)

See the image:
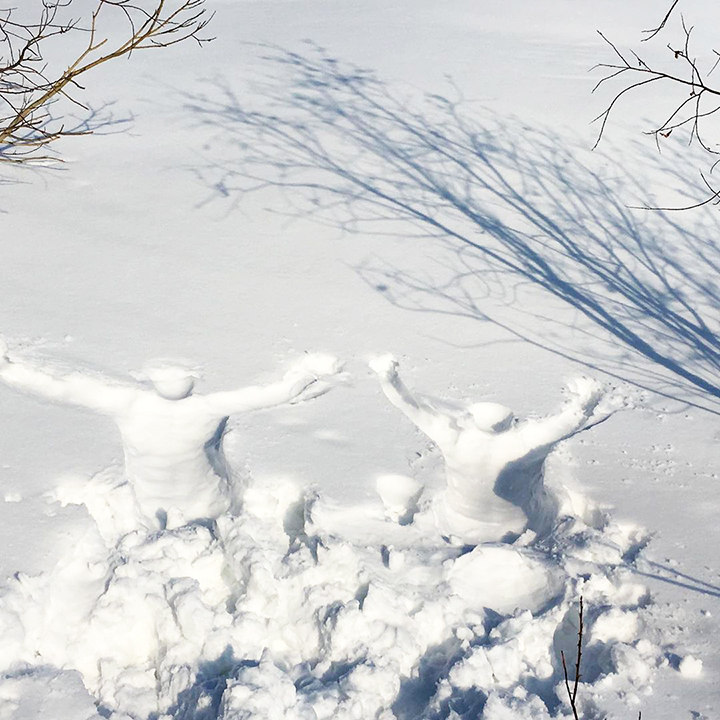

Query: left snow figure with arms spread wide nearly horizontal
(0, 340), (340, 529)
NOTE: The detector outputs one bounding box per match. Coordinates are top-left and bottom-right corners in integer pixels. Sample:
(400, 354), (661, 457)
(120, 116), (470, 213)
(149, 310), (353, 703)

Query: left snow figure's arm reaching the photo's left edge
(0, 338), (136, 414)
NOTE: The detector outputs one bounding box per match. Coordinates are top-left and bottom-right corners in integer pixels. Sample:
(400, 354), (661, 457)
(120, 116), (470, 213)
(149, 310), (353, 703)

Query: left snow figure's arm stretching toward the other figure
(203, 353), (342, 416)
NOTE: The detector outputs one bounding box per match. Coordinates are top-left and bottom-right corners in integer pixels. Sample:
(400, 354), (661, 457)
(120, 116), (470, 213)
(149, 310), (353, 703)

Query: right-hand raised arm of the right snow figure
(516, 377), (610, 448)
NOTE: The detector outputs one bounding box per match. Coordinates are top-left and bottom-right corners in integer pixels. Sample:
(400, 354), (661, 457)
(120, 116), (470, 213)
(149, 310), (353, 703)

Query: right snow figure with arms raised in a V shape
(370, 355), (611, 544)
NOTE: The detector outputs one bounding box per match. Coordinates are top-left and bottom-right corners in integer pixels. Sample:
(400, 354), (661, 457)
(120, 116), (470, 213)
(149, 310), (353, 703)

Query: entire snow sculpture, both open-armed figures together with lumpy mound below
(0, 347), (702, 720)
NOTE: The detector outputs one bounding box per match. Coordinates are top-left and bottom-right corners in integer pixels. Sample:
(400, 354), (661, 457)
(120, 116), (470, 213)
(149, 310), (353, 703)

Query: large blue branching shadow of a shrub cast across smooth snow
(185, 48), (720, 412)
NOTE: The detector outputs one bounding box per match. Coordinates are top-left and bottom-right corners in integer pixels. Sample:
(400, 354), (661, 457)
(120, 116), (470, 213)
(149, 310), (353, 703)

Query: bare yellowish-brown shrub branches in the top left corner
(0, 0), (212, 163)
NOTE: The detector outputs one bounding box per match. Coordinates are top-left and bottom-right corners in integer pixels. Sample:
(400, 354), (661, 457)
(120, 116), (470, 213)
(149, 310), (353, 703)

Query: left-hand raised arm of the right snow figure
(368, 355), (458, 445)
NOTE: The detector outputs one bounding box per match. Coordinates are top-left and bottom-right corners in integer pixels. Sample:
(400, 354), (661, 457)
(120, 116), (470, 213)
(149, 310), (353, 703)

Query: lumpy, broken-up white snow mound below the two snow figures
(0, 468), (697, 720)
